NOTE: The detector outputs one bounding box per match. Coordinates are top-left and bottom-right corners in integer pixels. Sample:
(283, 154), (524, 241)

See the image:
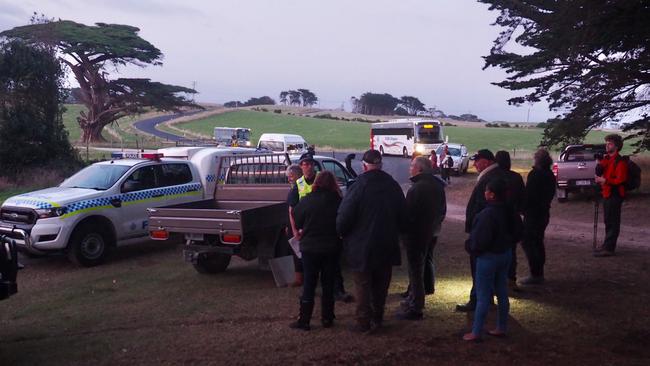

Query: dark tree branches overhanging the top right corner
(479, 0), (650, 150)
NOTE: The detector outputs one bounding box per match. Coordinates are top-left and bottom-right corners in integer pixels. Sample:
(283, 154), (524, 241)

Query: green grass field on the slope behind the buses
(165, 111), (631, 156)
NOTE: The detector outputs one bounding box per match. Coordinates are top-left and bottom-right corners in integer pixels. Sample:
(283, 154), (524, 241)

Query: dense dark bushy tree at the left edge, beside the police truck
(0, 41), (76, 175)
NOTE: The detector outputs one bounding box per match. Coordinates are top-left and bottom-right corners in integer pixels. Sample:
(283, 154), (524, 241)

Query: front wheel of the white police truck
(68, 225), (108, 267)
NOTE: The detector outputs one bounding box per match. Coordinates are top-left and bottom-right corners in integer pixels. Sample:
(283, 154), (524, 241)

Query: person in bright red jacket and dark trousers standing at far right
(594, 134), (628, 257)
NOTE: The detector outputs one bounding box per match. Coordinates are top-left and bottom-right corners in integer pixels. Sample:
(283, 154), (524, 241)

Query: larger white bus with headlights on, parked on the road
(370, 118), (445, 157)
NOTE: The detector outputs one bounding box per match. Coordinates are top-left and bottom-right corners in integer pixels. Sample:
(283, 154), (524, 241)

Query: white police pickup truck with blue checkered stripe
(0, 147), (255, 266)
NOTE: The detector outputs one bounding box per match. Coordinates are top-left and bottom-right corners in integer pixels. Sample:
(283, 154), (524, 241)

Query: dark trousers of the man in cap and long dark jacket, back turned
(352, 263), (393, 326)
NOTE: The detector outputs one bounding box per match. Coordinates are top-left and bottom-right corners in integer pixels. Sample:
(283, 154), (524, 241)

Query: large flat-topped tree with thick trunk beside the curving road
(0, 20), (198, 142)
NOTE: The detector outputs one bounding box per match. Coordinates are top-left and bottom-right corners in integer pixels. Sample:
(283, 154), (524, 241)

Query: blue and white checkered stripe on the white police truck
(5, 183), (201, 218)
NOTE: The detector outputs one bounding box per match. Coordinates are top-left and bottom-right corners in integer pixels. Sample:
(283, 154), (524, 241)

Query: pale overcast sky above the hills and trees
(0, 0), (555, 121)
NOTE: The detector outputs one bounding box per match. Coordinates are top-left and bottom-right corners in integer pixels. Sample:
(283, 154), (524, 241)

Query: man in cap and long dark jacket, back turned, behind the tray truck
(336, 149), (407, 332)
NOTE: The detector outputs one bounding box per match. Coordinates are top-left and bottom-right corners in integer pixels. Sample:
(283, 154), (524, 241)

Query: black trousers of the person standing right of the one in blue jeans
(521, 210), (549, 277)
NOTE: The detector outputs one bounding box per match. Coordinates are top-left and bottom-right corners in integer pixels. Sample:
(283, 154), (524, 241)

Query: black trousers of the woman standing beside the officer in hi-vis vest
(300, 251), (340, 319)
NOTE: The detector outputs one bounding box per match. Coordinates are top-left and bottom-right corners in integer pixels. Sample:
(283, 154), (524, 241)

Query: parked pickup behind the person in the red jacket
(553, 144), (605, 202)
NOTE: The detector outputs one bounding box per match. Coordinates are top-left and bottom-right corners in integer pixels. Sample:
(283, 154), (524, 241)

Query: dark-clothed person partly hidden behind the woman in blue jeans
(494, 150), (526, 291)
